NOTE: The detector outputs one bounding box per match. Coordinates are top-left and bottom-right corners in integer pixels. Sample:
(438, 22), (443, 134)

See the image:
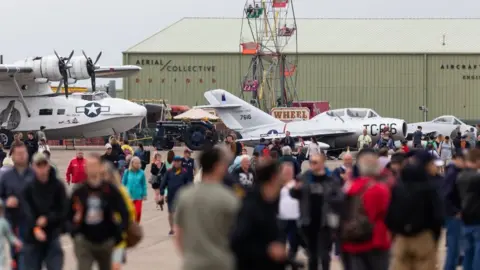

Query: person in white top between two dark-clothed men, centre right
(278, 162), (300, 262)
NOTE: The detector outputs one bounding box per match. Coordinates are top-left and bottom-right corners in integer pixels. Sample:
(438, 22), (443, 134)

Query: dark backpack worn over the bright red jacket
(340, 183), (374, 243)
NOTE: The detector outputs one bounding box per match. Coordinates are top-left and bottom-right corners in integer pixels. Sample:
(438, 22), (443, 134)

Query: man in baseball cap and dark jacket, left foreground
(22, 153), (68, 269)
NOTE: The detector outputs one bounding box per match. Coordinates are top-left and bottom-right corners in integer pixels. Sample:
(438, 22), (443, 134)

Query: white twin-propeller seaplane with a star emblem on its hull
(0, 51), (147, 147)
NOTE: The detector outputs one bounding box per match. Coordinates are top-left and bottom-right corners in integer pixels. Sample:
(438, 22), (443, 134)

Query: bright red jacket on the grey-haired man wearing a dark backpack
(343, 177), (391, 253)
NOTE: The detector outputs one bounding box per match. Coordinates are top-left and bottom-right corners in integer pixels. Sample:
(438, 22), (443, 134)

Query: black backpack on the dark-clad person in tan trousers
(385, 181), (431, 236)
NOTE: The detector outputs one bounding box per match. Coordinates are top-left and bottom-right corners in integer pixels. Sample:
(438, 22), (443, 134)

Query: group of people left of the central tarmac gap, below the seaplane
(0, 134), (148, 270)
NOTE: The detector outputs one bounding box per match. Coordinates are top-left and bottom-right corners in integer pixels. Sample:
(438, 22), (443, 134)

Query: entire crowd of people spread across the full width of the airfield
(0, 126), (480, 270)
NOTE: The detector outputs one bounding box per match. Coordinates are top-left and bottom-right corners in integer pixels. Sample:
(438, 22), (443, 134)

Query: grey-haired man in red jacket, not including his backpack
(342, 149), (391, 270)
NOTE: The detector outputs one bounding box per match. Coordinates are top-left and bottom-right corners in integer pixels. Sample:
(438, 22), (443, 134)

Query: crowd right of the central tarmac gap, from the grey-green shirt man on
(167, 129), (480, 270)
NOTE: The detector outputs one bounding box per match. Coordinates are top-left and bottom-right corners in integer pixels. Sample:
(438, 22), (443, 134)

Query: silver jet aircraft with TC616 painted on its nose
(200, 89), (407, 155)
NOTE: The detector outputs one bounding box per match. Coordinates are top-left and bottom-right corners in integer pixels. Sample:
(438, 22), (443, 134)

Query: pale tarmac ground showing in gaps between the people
(43, 147), (452, 270)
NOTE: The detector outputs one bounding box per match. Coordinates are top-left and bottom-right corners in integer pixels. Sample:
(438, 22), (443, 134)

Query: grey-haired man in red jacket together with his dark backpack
(340, 149), (390, 270)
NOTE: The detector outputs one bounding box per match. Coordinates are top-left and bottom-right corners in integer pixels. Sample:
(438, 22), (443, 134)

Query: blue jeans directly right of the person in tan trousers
(443, 217), (463, 270)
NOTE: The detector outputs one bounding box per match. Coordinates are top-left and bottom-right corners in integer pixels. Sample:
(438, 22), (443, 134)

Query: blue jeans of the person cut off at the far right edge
(463, 225), (480, 270)
